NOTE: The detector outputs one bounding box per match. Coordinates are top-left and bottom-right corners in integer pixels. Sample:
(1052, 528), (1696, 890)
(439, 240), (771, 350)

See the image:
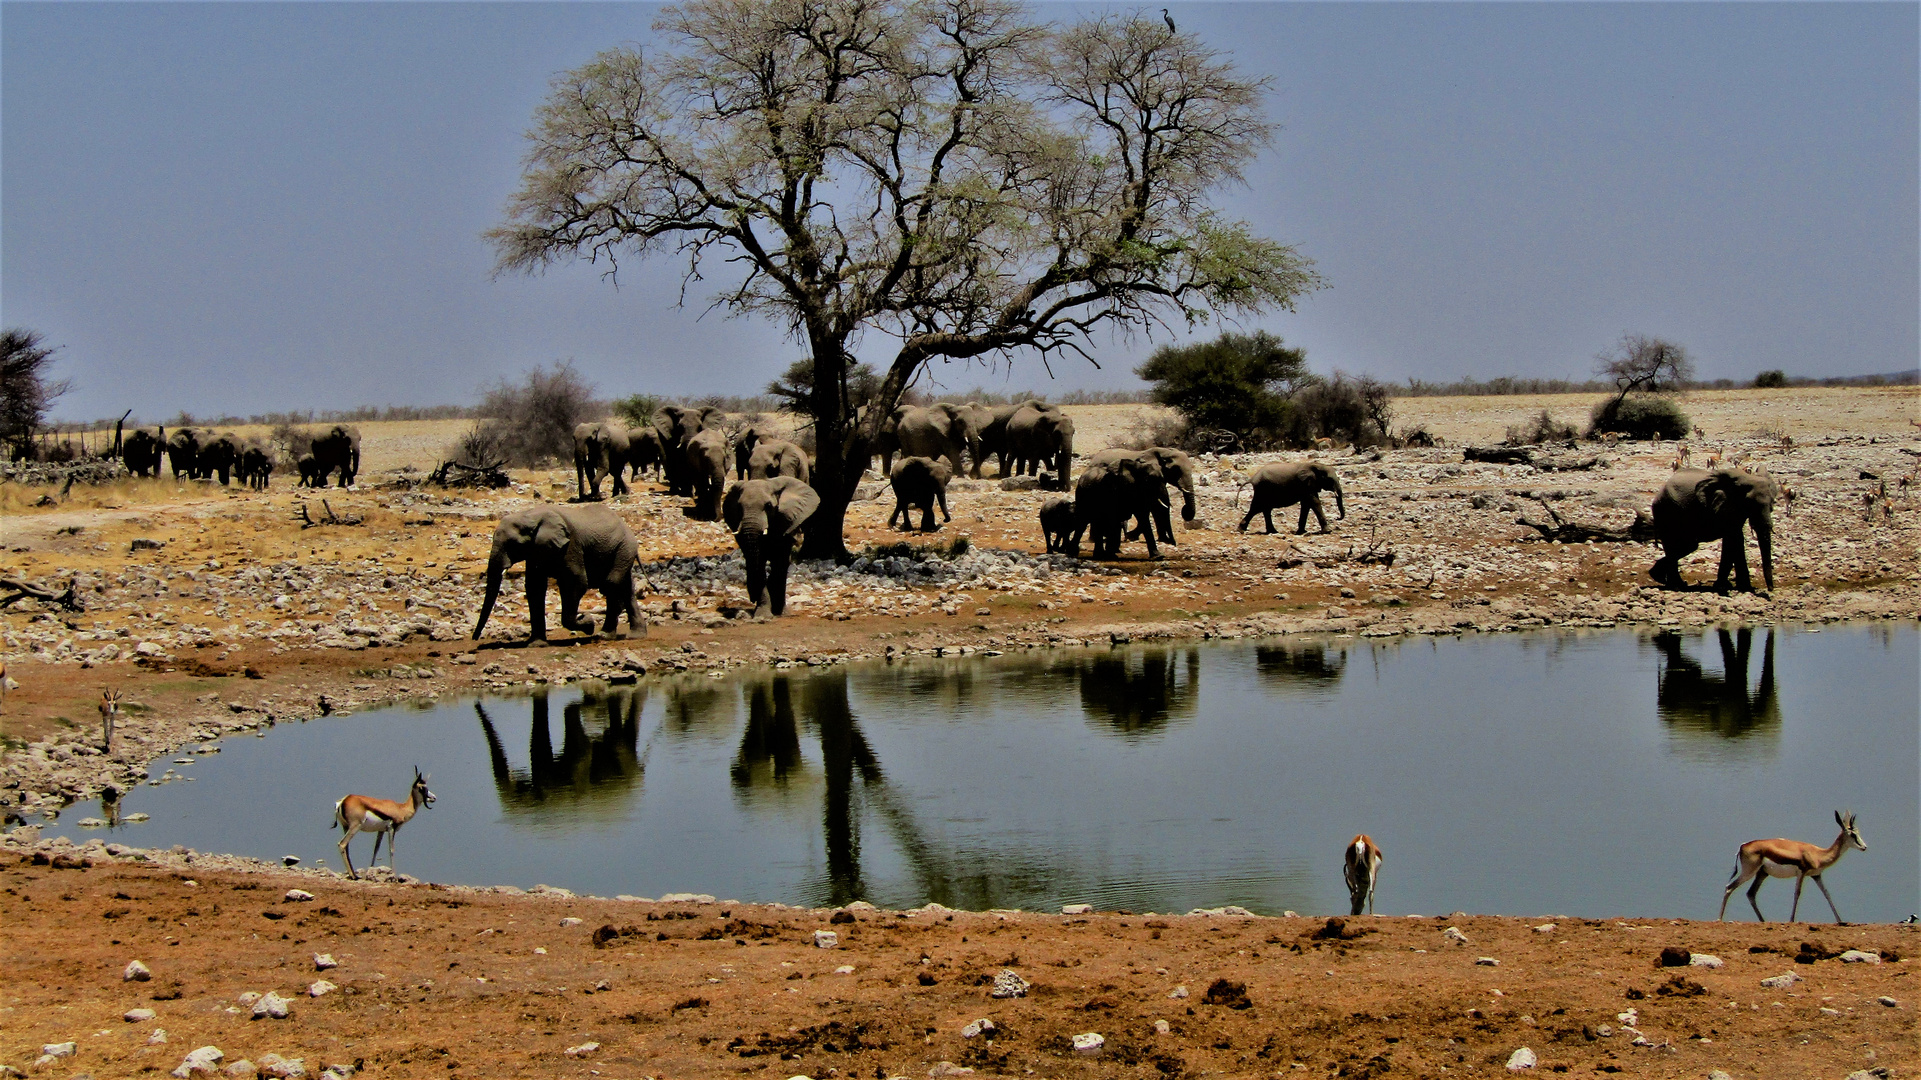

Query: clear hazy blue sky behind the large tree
(0, 2), (1921, 421)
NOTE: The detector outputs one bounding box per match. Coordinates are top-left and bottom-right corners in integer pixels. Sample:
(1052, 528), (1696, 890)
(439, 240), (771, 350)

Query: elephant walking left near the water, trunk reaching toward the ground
(474, 503), (647, 644)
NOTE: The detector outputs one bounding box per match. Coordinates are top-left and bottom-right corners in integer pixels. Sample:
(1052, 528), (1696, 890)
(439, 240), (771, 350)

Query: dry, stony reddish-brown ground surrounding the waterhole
(0, 388), (1921, 1076)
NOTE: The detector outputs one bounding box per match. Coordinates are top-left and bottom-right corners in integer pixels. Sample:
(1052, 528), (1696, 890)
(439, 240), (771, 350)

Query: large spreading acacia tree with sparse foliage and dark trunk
(488, 0), (1320, 557)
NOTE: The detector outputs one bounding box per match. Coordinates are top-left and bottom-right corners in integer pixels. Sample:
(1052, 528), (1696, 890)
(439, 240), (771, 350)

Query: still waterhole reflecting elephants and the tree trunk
(61, 623), (1921, 920)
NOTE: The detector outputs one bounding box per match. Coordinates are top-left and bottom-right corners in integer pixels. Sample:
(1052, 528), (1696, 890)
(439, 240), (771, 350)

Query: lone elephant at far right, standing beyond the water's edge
(1648, 469), (1777, 592)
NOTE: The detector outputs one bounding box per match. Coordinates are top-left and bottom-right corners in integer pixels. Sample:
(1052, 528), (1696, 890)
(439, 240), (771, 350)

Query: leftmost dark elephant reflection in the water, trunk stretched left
(474, 688), (645, 813)
